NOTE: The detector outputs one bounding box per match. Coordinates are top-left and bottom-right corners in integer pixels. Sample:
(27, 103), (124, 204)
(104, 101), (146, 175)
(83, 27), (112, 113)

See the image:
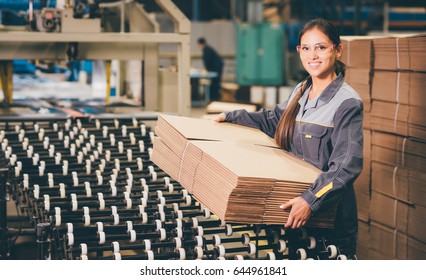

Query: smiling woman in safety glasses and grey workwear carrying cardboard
(215, 19), (363, 259)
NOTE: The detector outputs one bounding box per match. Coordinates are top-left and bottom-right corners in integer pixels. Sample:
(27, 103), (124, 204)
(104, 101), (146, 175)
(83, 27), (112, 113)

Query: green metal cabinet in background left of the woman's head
(237, 23), (284, 85)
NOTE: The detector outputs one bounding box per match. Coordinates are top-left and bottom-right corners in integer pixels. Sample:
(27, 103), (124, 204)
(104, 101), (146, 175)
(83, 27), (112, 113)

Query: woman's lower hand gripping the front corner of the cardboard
(280, 196), (311, 228)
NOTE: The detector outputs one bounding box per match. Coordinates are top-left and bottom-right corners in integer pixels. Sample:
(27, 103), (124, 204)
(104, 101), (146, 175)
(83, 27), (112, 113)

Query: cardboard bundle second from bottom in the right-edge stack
(370, 191), (426, 242)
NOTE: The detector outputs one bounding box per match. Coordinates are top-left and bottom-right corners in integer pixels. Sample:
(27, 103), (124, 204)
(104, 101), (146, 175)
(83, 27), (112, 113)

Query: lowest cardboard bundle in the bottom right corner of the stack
(368, 221), (426, 260)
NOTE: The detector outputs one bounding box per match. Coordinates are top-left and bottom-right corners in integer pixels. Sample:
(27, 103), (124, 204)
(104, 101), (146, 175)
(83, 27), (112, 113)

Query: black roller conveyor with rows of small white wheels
(0, 116), (346, 260)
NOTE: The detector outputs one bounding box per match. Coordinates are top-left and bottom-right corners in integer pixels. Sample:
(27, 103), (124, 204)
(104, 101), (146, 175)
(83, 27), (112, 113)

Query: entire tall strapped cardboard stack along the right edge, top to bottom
(370, 34), (426, 259)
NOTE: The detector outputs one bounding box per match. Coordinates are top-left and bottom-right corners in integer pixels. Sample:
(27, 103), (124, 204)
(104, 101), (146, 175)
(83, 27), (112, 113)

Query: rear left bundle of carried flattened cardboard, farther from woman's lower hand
(153, 115), (278, 192)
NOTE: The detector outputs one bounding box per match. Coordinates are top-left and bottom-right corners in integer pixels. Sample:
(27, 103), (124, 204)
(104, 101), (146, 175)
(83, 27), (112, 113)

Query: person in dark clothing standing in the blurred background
(198, 38), (223, 101)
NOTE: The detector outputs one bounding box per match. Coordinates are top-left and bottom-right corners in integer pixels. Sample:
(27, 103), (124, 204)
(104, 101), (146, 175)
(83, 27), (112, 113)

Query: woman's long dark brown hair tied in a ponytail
(274, 18), (345, 151)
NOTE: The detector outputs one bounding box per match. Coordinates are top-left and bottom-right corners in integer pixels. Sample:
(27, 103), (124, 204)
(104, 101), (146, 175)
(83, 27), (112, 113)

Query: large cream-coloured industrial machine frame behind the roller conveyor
(0, 0), (190, 115)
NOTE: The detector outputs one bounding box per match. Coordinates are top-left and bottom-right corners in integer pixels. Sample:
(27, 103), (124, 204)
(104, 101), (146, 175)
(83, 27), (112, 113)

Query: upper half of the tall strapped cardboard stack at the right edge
(371, 34), (426, 139)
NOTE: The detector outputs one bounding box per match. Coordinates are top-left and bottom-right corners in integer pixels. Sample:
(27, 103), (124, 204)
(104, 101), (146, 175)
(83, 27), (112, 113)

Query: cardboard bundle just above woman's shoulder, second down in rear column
(345, 68), (372, 112)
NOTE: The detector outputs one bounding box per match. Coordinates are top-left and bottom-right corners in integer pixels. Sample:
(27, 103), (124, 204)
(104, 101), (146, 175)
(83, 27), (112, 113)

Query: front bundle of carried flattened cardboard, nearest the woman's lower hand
(182, 141), (333, 227)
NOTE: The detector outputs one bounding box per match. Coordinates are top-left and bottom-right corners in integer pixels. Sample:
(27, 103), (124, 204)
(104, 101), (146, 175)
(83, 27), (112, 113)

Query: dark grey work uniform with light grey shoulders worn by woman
(225, 74), (363, 256)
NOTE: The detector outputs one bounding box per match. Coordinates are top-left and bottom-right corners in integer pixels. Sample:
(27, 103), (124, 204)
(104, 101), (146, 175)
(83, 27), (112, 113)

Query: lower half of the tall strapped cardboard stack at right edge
(370, 131), (426, 259)
